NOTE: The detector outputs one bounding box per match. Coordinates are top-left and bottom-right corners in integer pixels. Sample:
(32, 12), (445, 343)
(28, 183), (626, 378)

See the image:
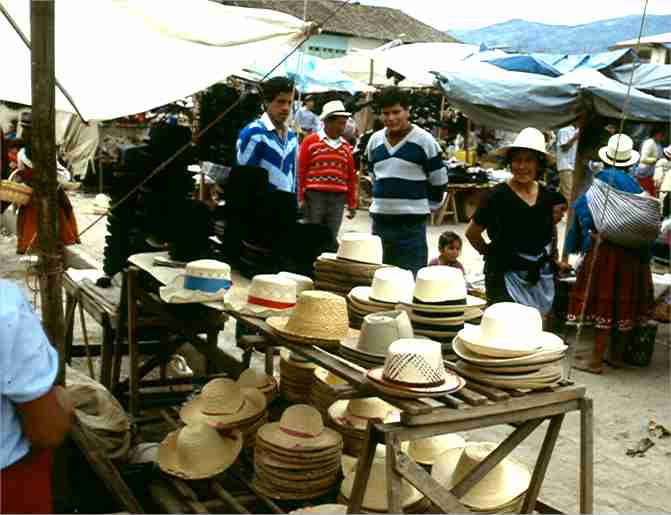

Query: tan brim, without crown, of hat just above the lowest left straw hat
(179, 388), (267, 429)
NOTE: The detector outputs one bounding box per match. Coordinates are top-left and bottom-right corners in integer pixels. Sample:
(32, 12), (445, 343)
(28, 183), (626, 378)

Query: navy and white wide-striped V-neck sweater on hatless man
(366, 125), (447, 215)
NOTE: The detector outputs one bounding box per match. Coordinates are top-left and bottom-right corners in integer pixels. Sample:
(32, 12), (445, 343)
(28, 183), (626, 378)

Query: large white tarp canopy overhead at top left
(0, 0), (307, 120)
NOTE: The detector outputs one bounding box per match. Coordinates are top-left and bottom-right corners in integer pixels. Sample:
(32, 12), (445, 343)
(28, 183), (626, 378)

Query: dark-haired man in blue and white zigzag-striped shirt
(236, 77), (298, 193)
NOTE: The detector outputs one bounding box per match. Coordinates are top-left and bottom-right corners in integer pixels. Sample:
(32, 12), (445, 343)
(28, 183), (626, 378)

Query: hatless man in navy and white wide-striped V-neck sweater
(366, 87), (447, 274)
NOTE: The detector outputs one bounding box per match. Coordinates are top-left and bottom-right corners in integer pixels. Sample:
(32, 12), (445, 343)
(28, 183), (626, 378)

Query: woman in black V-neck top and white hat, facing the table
(466, 127), (554, 314)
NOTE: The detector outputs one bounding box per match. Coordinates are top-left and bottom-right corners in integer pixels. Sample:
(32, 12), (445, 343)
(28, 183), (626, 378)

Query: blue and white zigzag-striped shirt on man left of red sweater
(235, 113), (298, 193)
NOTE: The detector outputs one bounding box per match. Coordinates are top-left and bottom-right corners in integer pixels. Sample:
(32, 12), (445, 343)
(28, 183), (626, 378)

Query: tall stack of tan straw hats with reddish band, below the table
(254, 404), (342, 500)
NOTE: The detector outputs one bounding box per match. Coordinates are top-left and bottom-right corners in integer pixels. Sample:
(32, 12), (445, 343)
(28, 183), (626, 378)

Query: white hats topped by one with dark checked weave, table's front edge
(366, 338), (466, 398)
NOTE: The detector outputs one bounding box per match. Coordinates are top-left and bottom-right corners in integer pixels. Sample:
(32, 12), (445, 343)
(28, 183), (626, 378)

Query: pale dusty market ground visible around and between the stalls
(0, 193), (671, 513)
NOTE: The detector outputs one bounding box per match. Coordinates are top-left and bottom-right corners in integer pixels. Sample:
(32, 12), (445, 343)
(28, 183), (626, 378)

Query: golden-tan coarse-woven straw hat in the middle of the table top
(267, 290), (349, 346)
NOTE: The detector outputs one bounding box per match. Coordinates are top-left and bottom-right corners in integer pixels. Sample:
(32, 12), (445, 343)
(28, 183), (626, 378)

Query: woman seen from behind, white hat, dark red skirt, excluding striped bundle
(564, 134), (653, 374)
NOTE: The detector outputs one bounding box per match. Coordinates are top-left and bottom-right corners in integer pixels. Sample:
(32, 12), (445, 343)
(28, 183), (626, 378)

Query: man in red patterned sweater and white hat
(297, 100), (357, 249)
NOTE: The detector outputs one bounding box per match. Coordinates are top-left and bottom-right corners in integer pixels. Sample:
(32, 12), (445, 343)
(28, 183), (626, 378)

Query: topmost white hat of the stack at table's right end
(457, 302), (563, 358)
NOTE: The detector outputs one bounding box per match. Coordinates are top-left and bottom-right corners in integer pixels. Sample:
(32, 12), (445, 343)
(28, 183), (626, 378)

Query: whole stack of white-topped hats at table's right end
(453, 302), (567, 390)
